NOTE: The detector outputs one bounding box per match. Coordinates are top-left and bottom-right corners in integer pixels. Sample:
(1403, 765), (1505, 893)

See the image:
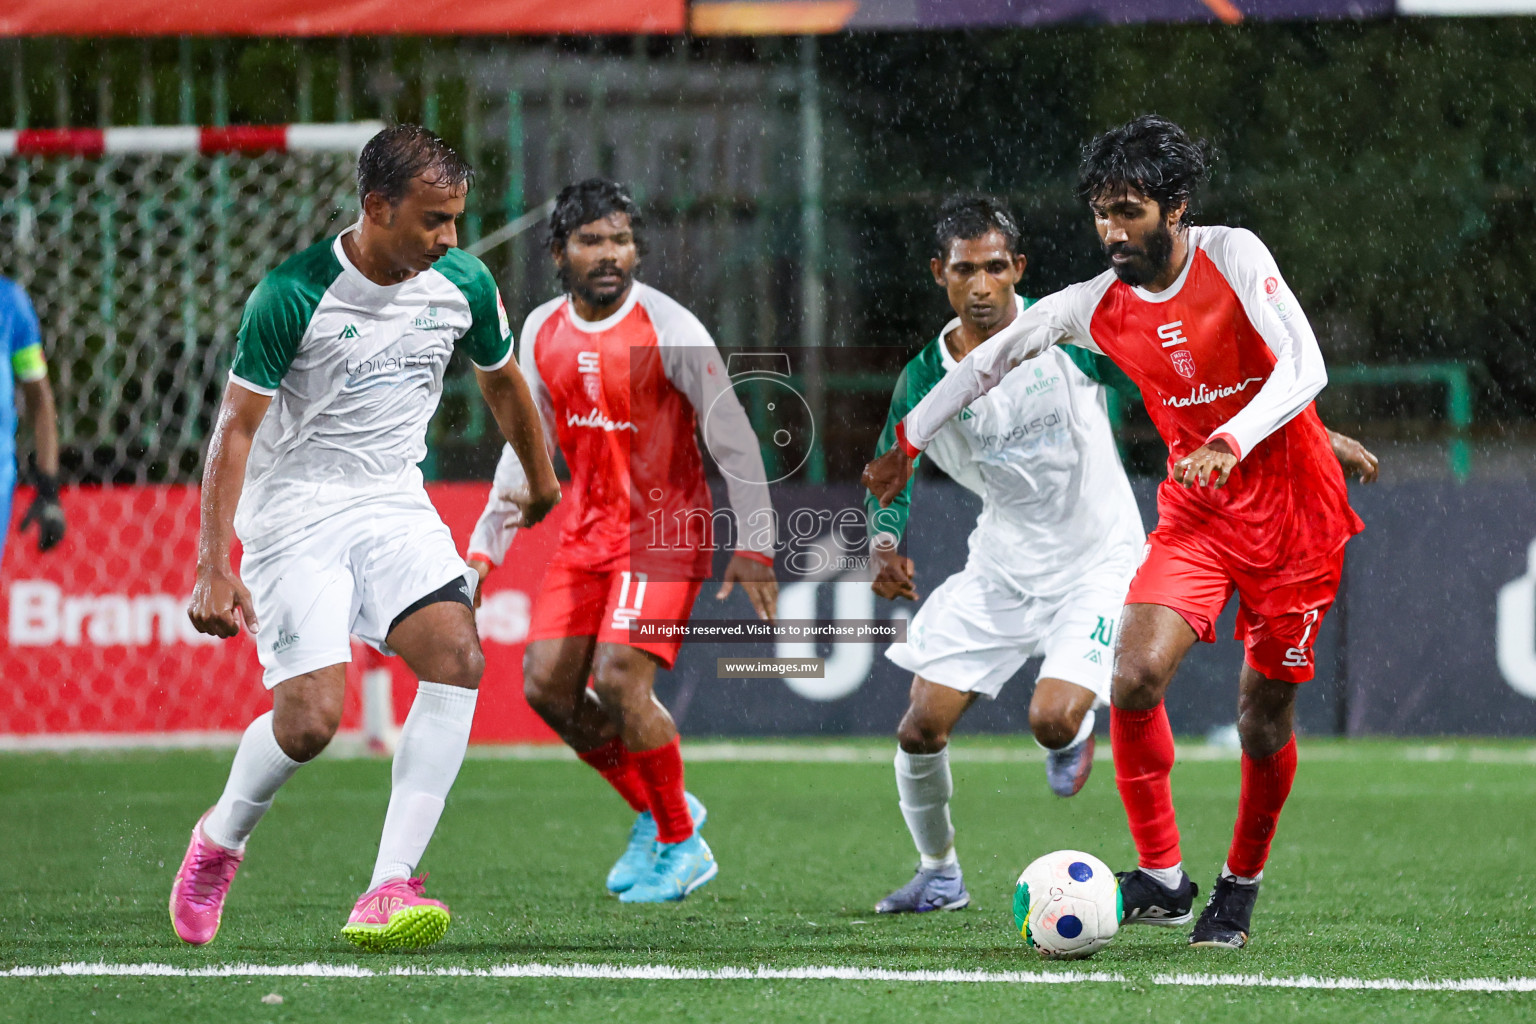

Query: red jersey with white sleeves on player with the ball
(902, 227), (1362, 570)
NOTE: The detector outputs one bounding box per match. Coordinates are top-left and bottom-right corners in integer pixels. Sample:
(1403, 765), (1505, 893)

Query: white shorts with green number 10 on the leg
(885, 567), (1132, 703)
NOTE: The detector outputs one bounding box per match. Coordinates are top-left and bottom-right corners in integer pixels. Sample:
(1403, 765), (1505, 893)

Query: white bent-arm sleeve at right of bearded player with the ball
(1206, 229), (1329, 459)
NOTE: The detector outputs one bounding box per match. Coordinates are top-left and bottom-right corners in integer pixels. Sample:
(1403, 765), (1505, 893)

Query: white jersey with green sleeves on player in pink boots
(229, 229), (511, 548)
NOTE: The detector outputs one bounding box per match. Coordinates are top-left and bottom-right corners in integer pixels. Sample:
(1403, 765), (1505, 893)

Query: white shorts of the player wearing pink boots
(240, 494), (476, 689)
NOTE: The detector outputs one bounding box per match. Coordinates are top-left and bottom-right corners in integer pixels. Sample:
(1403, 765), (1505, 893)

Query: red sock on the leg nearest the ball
(1109, 703), (1183, 867)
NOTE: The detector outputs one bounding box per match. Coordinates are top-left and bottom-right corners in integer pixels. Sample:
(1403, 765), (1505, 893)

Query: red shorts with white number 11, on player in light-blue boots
(528, 565), (702, 668)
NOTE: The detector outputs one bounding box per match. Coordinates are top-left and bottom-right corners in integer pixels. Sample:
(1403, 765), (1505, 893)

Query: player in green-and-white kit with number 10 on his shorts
(865, 195), (1146, 913)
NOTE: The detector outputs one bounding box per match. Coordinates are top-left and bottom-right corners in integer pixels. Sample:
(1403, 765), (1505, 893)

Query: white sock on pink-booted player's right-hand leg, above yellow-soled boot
(369, 683), (478, 889)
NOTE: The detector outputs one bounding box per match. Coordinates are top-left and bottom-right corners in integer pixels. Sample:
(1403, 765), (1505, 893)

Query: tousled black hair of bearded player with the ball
(1075, 114), (1210, 223)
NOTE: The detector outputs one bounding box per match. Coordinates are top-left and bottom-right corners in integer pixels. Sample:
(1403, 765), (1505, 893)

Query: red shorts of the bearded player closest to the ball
(1126, 530), (1344, 683)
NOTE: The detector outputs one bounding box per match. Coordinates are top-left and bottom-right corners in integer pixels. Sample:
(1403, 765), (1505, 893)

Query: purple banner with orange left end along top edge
(690, 0), (1396, 35)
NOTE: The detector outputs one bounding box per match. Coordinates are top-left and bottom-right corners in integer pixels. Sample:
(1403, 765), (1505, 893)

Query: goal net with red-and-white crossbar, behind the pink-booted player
(0, 123), (382, 745)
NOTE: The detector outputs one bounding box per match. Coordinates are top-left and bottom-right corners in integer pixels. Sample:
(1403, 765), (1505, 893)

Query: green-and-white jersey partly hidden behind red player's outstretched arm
(865, 299), (1146, 597)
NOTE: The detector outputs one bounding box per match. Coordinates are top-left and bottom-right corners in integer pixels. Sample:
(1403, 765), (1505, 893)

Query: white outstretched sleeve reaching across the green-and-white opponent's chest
(897, 281), (1098, 456)
